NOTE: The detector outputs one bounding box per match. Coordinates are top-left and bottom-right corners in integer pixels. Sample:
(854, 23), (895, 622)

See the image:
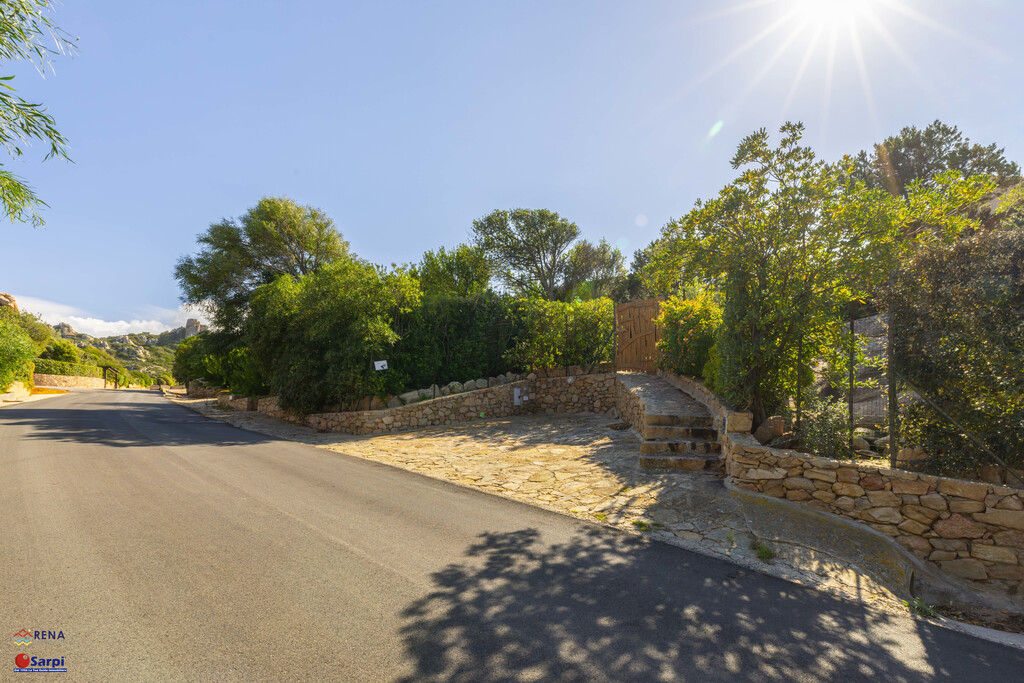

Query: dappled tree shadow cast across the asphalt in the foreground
(402, 528), (1024, 682)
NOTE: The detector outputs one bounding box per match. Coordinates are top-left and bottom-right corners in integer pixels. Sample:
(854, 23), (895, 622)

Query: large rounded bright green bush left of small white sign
(246, 259), (420, 413)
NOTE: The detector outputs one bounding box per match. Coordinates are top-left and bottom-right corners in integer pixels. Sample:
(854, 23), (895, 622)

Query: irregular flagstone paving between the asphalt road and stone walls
(176, 398), (905, 611)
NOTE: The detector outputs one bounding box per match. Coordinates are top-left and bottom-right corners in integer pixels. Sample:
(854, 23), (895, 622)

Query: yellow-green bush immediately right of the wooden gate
(657, 293), (722, 375)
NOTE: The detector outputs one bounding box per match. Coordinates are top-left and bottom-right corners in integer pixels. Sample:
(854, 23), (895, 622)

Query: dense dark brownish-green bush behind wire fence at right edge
(885, 223), (1024, 474)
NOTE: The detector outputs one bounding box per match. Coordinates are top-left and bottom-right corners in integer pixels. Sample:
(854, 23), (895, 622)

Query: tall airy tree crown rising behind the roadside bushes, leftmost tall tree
(174, 197), (348, 333)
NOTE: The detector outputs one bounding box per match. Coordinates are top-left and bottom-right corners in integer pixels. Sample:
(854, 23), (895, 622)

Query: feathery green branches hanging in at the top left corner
(0, 0), (75, 226)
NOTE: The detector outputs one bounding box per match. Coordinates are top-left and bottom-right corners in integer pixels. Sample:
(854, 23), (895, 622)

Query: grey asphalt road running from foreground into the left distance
(0, 391), (1024, 683)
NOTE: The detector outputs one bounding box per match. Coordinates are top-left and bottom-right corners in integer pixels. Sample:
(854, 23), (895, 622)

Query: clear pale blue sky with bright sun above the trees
(8, 0), (1024, 334)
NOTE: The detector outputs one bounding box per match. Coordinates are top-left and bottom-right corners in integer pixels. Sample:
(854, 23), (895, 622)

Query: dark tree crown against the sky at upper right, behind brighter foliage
(854, 121), (1020, 197)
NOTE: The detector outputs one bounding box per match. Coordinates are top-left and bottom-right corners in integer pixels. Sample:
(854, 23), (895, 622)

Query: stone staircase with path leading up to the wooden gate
(618, 373), (723, 471)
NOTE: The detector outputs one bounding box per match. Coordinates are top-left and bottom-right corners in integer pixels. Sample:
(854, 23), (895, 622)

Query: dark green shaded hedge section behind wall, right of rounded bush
(387, 291), (520, 389)
